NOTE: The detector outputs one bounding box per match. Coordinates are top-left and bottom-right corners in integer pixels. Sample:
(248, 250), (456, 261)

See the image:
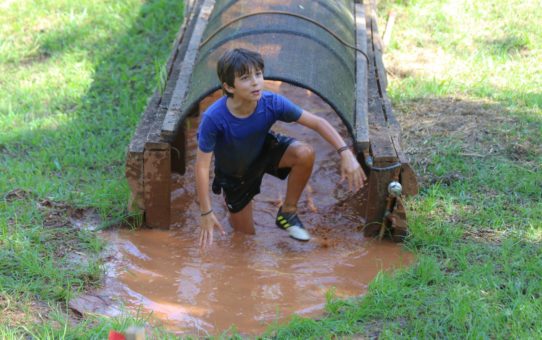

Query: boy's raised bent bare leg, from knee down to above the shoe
(278, 141), (315, 212)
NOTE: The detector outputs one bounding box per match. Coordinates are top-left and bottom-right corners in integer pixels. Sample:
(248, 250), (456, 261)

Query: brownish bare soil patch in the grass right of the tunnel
(394, 98), (542, 186)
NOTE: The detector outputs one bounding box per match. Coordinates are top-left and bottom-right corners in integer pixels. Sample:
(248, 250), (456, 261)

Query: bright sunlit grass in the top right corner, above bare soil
(381, 1), (542, 109)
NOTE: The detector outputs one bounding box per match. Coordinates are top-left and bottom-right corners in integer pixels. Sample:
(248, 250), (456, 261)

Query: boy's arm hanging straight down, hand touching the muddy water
(195, 148), (224, 247)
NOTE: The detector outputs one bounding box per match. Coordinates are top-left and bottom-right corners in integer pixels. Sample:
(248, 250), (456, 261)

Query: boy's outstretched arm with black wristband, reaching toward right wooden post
(297, 110), (367, 191)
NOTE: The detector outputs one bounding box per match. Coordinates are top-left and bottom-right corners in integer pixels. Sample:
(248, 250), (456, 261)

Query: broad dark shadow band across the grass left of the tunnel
(0, 0), (183, 215)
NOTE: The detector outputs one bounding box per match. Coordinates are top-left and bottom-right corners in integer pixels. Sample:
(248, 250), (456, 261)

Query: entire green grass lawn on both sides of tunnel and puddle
(0, 0), (542, 339)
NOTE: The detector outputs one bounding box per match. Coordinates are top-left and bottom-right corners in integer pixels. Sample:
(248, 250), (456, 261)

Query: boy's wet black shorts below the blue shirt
(213, 132), (295, 213)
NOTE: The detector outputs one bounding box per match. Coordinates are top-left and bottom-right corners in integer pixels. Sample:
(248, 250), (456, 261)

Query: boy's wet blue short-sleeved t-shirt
(198, 91), (302, 177)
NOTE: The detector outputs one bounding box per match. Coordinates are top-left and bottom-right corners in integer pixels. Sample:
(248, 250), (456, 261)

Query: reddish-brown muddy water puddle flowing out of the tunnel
(107, 82), (412, 335)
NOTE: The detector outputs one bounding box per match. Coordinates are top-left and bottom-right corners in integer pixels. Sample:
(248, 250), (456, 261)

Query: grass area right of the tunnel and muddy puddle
(267, 0), (542, 339)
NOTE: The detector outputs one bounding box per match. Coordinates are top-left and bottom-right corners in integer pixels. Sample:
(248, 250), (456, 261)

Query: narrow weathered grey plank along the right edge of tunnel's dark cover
(354, 4), (369, 153)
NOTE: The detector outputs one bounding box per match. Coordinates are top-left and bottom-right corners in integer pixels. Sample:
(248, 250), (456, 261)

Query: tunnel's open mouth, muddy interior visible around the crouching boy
(170, 80), (367, 231)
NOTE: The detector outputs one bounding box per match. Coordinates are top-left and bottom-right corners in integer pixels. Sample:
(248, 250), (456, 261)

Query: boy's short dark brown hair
(216, 48), (264, 97)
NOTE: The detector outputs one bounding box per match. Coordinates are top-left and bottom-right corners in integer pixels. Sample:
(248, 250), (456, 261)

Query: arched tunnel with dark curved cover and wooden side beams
(126, 0), (417, 240)
